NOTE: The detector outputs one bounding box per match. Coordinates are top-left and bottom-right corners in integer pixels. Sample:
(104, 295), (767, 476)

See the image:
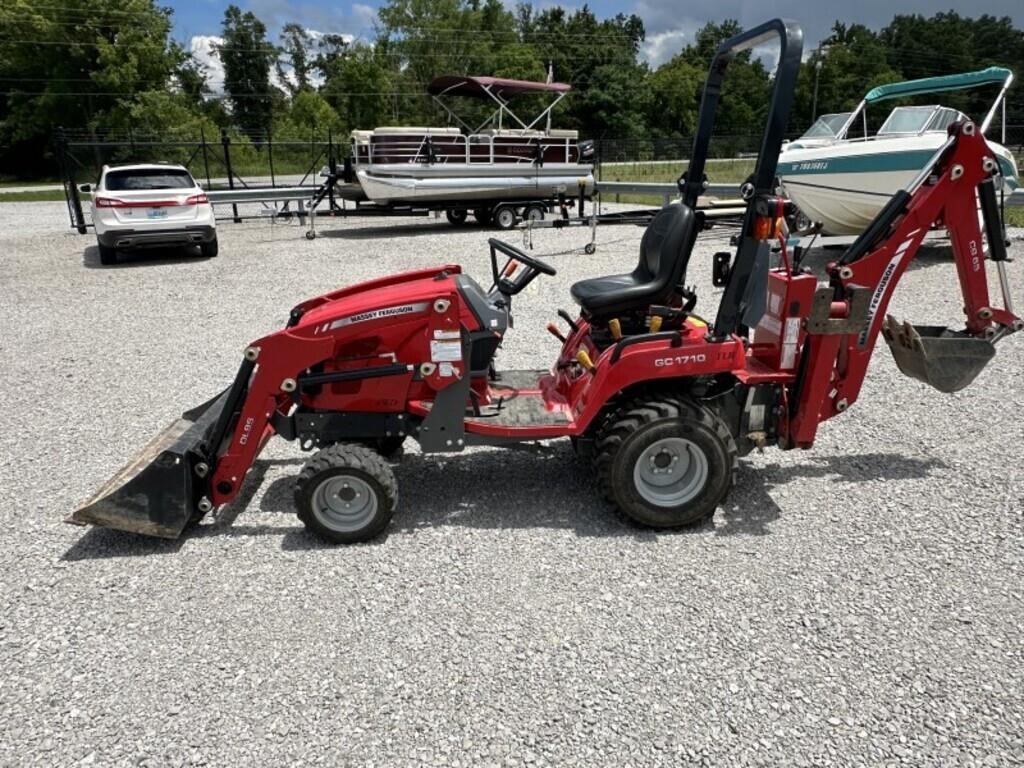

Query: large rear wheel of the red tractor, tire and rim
(595, 396), (736, 528)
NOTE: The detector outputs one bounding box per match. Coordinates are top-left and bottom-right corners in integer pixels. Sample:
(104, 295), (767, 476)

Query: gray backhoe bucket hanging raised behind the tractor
(882, 315), (995, 392)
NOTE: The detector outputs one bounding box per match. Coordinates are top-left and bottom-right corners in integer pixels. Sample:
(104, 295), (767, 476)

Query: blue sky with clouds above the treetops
(162, 0), (1024, 70)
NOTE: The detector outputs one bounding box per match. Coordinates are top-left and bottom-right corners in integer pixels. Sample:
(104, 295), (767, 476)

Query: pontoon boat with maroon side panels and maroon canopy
(351, 75), (594, 217)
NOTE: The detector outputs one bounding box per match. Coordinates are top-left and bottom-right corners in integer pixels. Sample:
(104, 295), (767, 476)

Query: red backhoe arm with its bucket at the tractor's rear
(787, 123), (1024, 447)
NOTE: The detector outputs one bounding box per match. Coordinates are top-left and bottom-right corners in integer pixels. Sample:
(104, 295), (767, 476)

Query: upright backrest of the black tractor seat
(633, 203), (697, 303)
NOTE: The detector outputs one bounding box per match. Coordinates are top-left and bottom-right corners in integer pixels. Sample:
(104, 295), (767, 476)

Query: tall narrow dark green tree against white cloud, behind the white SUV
(217, 5), (278, 138)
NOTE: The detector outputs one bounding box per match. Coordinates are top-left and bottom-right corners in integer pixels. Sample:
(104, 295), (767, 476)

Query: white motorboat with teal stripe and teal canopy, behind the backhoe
(778, 67), (1019, 234)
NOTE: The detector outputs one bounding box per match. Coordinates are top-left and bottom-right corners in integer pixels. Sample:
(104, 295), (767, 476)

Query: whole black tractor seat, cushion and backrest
(569, 203), (697, 317)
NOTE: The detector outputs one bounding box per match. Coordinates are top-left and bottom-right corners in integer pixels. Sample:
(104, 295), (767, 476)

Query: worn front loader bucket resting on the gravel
(67, 392), (227, 539)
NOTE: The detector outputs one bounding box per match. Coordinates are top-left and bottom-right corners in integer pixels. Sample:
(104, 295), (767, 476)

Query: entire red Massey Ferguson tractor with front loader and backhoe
(71, 20), (1024, 542)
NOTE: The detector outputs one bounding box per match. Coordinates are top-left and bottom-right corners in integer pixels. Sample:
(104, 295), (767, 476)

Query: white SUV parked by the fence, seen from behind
(82, 164), (217, 264)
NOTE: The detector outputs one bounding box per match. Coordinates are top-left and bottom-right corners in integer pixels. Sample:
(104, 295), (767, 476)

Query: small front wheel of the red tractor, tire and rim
(295, 442), (398, 544)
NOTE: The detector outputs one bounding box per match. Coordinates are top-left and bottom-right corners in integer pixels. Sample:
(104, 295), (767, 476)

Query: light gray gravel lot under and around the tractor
(0, 204), (1024, 767)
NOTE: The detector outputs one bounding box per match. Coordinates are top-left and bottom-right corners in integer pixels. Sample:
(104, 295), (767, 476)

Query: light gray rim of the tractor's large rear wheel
(633, 437), (708, 507)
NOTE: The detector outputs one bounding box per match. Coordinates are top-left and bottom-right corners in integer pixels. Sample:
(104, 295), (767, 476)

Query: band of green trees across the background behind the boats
(0, 0), (1024, 177)
